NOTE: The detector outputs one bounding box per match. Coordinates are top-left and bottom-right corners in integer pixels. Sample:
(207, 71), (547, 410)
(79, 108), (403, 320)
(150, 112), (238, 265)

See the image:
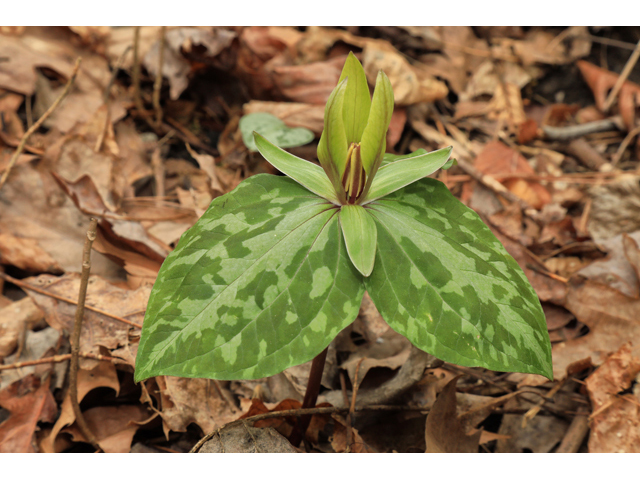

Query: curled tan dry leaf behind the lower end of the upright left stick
(40, 362), (120, 453)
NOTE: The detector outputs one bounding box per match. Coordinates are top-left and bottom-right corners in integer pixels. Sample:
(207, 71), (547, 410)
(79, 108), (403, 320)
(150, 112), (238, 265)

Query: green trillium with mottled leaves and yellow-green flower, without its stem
(135, 54), (552, 392)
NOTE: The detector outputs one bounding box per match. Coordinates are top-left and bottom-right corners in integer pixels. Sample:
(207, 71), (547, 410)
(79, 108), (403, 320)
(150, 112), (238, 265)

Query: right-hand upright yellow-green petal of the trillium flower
(361, 70), (393, 176)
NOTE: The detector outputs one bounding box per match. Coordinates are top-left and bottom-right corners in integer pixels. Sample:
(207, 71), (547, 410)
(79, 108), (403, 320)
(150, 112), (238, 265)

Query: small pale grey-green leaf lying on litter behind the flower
(239, 112), (314, 152)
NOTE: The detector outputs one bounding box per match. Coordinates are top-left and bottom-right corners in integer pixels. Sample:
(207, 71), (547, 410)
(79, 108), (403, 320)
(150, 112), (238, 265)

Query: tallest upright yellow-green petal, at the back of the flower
(338, 52), (371, 145)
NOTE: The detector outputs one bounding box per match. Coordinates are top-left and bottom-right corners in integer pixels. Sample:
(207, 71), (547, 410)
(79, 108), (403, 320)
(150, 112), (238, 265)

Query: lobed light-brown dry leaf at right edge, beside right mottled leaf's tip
(552, 276), (640, 380)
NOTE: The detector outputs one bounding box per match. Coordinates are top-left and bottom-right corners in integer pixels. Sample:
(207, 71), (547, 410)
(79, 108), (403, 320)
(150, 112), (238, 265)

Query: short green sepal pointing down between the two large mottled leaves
(340, 205), (376, 277)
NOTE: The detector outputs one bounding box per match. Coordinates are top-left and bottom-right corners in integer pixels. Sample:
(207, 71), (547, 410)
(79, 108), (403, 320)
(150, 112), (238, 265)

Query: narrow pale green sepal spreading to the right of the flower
(362, 147), (453, 205)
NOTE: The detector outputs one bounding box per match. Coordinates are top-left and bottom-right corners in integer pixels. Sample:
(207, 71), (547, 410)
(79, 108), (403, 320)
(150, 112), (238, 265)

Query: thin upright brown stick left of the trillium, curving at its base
(69, 218), (100, 449)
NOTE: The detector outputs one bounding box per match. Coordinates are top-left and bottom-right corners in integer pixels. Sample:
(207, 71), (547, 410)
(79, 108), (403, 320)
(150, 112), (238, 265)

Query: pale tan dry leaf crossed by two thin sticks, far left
(25, 274), (151, 367)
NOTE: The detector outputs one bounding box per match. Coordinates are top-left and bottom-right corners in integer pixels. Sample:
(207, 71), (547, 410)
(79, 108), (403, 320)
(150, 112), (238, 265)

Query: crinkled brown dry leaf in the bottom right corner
(586, 343), (640, 453)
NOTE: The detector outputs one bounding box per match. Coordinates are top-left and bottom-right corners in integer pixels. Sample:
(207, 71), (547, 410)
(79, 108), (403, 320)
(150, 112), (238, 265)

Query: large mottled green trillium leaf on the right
(365, 178), (553, 378)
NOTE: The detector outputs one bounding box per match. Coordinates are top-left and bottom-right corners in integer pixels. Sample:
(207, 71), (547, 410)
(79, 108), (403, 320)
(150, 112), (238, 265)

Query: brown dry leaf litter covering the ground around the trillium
(0, 27), (640, 452)
